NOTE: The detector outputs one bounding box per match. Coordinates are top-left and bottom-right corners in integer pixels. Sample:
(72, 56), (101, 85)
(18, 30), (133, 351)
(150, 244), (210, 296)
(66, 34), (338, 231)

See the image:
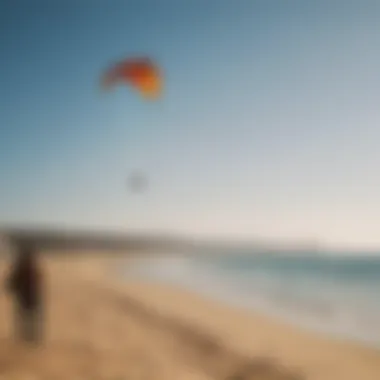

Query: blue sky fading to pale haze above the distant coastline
(0, 0), (380, 247)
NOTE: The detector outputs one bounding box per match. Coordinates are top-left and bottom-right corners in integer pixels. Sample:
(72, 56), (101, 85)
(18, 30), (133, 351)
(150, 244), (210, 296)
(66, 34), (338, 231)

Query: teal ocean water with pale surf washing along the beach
(123, 252), (380, 347)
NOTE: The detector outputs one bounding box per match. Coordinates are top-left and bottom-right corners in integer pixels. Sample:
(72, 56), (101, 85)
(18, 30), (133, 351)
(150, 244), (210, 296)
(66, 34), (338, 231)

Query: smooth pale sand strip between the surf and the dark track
(104, 274), (380, 380)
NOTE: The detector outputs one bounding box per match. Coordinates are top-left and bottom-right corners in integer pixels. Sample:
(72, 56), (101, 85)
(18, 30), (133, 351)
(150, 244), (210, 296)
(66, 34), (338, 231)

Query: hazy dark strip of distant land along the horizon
(0, 226), (317, 255)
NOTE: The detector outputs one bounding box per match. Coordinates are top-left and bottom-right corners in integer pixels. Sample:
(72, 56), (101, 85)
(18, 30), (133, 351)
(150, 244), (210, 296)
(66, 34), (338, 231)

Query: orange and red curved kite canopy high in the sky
(102, 58), (162, 100)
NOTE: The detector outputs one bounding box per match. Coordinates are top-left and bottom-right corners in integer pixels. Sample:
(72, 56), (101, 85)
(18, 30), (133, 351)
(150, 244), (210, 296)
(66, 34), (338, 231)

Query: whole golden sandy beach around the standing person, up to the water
(0, 249), (380, 380)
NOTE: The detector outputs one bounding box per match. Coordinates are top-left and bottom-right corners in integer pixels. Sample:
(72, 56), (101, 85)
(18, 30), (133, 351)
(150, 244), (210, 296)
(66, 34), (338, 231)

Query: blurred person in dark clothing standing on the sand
(7, 245), (42, 342)
